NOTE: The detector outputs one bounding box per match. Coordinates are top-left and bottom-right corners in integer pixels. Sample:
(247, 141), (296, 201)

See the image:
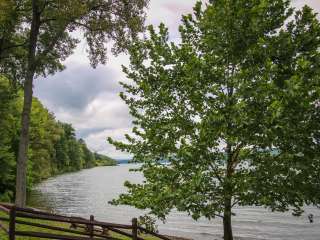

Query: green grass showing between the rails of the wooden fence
(0, 211), (159, 240)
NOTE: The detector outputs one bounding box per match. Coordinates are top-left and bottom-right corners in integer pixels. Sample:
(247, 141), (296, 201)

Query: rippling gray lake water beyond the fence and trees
(31, 164), (320, 240)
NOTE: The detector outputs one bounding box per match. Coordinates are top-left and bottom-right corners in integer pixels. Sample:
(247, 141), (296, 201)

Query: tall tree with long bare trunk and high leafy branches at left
(0, 0), (148, 206)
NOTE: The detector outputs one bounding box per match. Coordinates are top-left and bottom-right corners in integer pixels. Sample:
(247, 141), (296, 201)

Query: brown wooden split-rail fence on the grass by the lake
(0, 203), (170, 240)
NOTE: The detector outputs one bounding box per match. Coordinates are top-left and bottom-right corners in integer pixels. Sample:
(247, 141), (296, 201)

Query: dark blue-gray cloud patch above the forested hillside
(35, 65), (120, 112)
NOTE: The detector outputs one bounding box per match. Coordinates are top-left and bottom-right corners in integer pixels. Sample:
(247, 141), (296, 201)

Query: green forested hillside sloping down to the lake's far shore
(0, 75), (116, 201)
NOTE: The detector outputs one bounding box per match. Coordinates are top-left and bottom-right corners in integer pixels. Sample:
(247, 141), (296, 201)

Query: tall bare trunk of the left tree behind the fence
(15, 0), (40, 207)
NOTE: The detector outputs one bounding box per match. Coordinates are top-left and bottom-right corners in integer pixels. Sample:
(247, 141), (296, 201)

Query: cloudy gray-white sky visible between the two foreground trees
(35, 0), (320, 159)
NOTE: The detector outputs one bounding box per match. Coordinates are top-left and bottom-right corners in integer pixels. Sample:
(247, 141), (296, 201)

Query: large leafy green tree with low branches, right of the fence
(108, 0), (320, 240)
